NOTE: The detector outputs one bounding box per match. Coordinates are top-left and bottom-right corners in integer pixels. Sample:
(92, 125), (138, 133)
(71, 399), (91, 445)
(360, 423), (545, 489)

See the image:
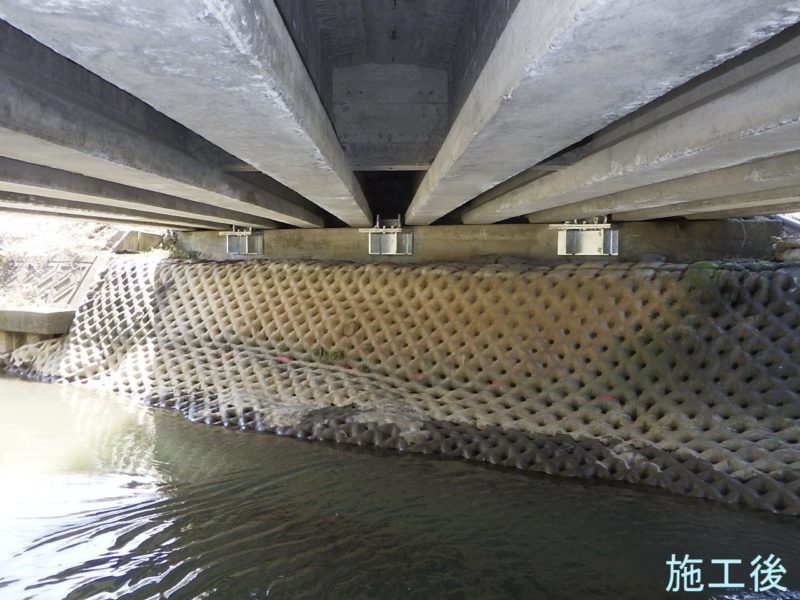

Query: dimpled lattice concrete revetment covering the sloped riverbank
(6, 261), (800, 514)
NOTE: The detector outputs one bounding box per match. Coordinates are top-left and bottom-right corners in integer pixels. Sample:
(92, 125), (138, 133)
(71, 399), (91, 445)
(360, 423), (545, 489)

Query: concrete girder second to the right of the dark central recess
(464, 34), (800, 223)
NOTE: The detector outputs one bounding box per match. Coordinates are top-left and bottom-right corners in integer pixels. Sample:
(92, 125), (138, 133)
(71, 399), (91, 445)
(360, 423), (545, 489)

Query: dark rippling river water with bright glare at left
(0, 379), (800, 599)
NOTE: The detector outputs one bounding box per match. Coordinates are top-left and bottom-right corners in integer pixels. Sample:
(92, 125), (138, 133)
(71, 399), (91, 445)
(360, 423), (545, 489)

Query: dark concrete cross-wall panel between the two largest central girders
(333, 64), (449, 171)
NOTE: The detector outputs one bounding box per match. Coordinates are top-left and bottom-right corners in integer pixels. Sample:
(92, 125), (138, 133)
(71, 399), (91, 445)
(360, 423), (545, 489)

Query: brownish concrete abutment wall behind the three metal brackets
(178, 221), (782, 264)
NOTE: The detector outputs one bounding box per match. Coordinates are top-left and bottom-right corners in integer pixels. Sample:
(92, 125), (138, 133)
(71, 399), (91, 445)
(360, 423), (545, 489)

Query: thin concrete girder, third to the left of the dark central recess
(0, 158), (277, 229)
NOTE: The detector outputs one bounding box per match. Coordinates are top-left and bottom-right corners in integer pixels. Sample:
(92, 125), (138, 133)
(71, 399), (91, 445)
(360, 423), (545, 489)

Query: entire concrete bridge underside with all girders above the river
(0, 0), (800, 236)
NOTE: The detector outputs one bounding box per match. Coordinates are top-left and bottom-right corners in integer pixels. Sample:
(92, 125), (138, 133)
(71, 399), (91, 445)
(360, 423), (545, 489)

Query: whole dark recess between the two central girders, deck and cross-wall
(276, 0), (518, 170)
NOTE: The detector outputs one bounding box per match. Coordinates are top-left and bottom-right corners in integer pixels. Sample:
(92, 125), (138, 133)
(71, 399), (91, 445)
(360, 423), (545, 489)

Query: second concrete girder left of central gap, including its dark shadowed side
(0, 22), (323, 227)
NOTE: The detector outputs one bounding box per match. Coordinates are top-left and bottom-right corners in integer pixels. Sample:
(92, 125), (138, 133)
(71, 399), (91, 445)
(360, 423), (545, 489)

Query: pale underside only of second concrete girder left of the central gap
(0, 79), (322, 226)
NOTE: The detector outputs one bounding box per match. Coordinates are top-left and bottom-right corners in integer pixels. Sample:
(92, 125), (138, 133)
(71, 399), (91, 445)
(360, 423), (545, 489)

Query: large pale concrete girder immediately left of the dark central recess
(0, 0), (372, 226)
